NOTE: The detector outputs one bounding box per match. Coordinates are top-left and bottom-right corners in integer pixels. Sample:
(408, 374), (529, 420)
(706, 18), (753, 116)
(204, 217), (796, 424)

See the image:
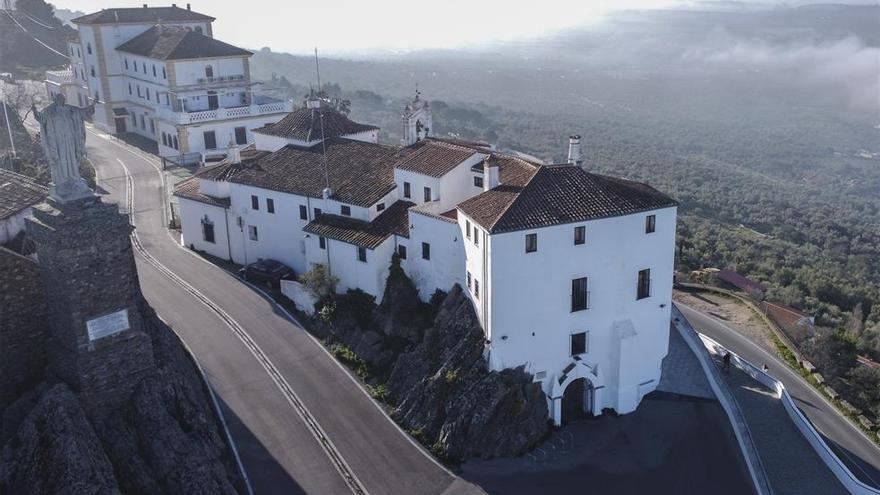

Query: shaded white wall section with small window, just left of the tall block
(399, 210), (465, 301)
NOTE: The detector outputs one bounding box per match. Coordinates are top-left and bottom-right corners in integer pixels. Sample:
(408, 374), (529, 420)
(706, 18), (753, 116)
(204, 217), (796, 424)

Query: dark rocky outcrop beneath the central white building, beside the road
(312, 258), (549, 461)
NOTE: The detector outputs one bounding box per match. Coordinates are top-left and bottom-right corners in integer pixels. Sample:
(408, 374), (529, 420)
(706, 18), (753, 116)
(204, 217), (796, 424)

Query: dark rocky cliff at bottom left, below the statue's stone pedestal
(0, 303), (245, 495)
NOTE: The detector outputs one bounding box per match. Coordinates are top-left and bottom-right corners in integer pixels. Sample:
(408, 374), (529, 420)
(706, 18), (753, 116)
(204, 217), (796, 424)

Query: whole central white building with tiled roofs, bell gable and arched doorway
(175, 96), (677, 423)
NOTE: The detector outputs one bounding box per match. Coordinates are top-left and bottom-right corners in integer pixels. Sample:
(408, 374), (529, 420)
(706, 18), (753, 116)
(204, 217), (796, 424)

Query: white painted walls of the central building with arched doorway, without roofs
(175, 93), (677, 424)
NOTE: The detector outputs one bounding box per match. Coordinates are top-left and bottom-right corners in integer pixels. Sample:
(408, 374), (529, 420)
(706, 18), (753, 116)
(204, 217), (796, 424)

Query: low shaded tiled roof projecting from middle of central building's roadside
(303, 201), (414, 249)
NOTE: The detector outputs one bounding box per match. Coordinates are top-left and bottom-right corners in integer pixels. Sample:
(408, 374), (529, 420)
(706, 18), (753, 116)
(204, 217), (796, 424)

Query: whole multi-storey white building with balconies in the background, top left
(63, 4), (292, 161)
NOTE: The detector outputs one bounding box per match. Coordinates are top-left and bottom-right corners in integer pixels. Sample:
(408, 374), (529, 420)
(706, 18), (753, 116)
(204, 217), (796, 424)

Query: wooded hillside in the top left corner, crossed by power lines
(0, 0), (76, 79)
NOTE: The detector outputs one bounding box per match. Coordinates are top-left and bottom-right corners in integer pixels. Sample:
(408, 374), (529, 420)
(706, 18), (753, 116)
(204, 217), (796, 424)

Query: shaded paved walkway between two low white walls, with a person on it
(716, 359), (847, 495)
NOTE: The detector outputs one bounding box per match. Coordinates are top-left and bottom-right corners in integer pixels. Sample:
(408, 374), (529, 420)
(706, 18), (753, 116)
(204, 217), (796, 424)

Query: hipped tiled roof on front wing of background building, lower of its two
(116, 26), (252, 60)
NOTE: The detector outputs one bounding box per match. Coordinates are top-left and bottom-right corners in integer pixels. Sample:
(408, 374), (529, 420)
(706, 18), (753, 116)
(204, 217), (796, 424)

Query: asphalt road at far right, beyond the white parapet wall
(676, 303), (880, 488)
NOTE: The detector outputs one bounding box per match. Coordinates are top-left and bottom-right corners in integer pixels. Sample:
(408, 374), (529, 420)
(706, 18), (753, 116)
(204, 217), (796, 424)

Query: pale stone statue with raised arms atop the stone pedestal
(33, 93), (95, 203)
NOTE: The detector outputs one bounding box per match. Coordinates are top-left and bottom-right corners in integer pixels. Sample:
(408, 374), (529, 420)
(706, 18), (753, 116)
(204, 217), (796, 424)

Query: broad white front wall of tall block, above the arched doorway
(484, 208), (676, 413)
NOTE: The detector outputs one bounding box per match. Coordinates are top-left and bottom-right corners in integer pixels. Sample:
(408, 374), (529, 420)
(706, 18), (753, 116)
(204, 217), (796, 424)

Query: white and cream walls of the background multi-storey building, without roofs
(68, 6), (292, 161)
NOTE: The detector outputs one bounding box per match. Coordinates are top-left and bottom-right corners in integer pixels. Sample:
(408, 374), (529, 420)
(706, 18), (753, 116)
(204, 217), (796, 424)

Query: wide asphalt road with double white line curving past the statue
(87, 130), (481, 495)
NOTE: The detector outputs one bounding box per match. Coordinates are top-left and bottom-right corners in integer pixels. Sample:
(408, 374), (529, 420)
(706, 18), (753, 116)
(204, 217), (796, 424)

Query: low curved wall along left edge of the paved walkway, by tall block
(672, 304), (773, 495)
